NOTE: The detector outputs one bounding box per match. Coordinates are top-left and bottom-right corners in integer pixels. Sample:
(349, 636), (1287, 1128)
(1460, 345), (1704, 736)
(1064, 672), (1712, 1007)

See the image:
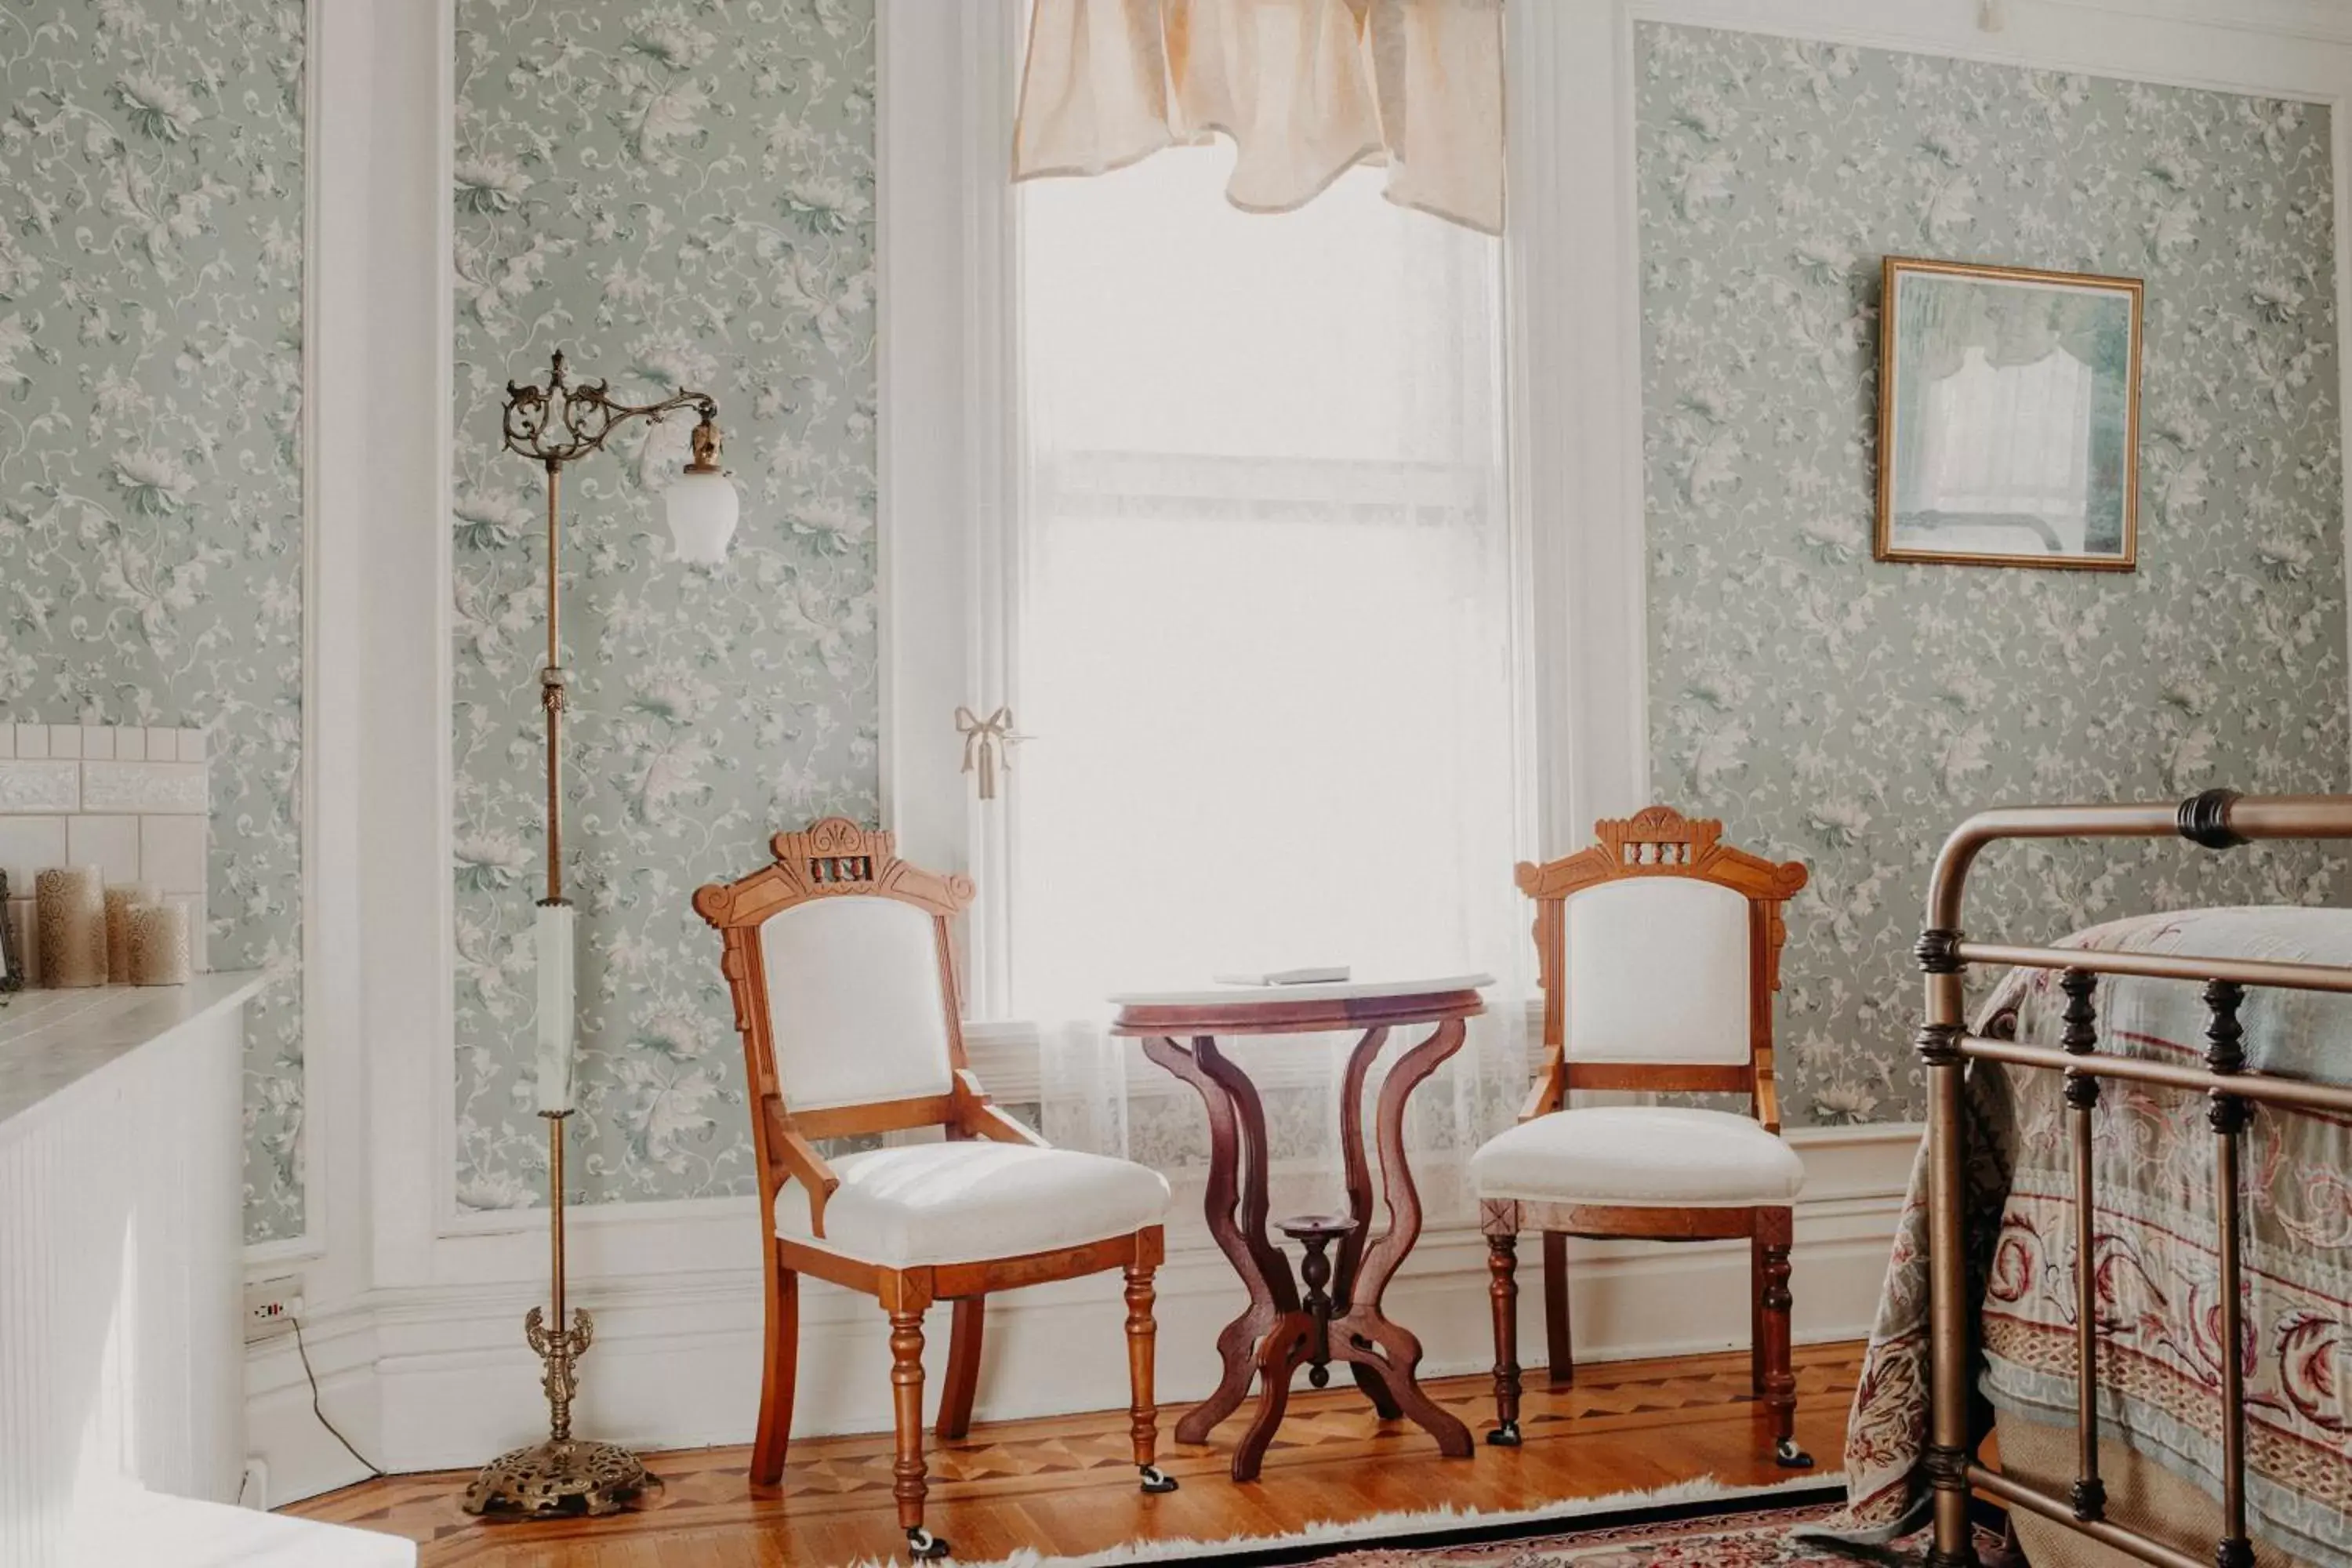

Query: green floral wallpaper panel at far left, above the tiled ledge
(0, 0), (303, 1241)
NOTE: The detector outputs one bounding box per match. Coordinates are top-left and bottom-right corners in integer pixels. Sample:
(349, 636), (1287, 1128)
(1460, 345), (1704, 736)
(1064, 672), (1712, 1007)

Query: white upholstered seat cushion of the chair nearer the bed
(1470, 1105), (1804, 1208)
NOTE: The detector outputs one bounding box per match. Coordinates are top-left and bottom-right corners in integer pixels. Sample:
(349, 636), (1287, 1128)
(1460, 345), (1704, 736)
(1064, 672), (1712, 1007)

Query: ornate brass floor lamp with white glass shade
(461, 353), (739, 1516)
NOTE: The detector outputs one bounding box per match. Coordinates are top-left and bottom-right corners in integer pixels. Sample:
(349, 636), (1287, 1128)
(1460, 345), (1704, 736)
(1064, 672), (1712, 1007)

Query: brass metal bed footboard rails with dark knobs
(1915, 789), (2352, 1568)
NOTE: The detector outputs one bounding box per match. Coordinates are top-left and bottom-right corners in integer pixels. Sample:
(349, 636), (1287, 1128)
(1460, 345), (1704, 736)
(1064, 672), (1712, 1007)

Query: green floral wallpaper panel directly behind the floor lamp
(452, 0), (880, 1208)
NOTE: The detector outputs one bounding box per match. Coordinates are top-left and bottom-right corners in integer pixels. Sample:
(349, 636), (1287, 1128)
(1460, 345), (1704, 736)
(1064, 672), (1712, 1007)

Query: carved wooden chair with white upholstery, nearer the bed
(1470, 806), (1813, 1469)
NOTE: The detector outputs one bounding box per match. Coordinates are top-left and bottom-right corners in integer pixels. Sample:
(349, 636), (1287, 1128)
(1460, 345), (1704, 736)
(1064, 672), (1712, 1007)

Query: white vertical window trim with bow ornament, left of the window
(875, 0), (1025, 1018)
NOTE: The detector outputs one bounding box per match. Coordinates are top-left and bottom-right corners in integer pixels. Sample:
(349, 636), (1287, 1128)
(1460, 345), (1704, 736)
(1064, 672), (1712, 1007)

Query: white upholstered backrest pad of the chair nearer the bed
(1566, 877), (1752, 1065)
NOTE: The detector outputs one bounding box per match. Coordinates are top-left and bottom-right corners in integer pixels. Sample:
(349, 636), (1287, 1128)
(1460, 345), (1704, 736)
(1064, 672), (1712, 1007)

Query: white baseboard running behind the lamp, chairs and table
(247, 1126), (1919, 1504)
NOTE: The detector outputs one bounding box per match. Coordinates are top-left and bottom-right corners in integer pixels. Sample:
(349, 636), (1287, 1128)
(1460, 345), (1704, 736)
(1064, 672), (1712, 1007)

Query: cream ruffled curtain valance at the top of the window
(1014, 0), (1503, 233)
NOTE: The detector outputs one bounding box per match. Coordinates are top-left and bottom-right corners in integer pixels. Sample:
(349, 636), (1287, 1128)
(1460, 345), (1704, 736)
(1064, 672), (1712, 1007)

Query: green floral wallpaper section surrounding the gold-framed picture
(1637, 26), (2347, 1123)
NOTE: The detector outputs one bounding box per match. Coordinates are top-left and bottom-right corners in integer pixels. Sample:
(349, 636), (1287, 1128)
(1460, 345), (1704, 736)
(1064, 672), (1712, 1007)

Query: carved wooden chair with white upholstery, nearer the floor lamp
(694, 815), (1176, 1556)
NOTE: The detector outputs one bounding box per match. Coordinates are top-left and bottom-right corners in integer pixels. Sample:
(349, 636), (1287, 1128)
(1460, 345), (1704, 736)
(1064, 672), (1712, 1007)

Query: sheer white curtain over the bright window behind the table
(1007, 148), (1531, 1220)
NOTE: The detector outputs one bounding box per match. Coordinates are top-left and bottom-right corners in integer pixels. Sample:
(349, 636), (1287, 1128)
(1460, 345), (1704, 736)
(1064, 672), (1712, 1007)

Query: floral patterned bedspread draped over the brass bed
(1839, 907), (2352, 1561)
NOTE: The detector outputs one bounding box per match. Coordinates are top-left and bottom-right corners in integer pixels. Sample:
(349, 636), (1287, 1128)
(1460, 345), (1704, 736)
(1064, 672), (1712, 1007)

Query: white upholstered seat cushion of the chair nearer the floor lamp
(776, 1140), (1169, 1267)
